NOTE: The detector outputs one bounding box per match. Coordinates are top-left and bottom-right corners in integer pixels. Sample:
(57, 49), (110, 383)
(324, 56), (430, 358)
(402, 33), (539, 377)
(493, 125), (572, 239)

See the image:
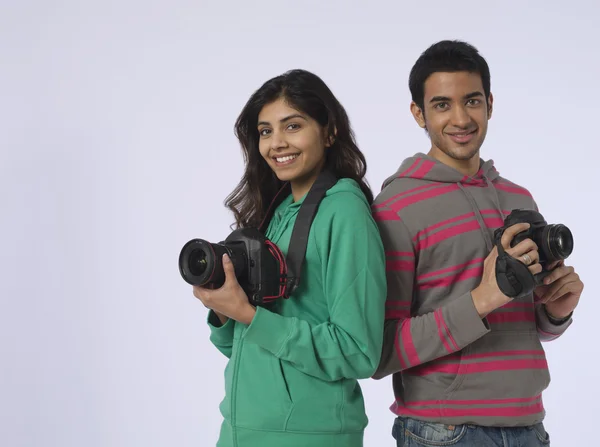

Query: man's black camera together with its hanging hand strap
(494, 209), (573, 298)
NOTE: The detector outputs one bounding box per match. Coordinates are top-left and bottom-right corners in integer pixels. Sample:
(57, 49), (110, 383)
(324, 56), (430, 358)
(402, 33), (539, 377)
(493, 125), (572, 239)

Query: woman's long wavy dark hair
(225, 70), (373, 228)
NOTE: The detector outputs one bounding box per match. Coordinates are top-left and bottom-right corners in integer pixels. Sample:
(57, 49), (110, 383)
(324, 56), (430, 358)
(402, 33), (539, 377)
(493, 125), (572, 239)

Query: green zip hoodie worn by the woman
(208, 179), (387, 447)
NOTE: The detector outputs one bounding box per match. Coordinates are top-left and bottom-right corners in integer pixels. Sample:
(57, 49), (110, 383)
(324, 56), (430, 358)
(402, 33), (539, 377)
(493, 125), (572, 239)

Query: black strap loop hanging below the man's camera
(495, 232), (537, 298)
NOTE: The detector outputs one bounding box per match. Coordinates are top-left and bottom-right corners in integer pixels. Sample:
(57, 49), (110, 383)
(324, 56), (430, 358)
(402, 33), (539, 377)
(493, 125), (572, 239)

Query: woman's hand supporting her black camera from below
(193, 255), (256, 324)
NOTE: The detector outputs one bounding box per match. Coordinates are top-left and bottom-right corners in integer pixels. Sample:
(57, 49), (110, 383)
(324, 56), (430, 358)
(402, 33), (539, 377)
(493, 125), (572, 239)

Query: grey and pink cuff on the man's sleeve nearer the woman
(443, 292), (490, 349)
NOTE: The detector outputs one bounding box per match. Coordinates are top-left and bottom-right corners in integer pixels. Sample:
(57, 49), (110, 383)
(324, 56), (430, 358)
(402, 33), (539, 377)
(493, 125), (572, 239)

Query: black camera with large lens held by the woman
(179, 228), (286, 306)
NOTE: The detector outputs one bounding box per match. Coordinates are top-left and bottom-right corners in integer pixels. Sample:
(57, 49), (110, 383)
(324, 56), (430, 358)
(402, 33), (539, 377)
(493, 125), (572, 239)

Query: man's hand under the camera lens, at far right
(534, 261), (583, 320)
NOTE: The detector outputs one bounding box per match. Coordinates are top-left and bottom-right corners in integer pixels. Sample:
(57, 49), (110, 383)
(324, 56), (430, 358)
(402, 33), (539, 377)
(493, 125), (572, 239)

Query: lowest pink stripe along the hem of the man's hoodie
(391, 401), (544, 418)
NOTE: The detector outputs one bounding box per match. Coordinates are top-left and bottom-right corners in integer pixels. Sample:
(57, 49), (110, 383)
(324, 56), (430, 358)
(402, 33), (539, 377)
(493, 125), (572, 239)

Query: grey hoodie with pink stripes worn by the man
(373, 153), (571, 426)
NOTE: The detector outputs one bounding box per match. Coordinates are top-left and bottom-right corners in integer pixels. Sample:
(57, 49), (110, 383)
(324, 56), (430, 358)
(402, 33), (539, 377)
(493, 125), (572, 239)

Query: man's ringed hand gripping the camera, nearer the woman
(471, 223), (542, 318)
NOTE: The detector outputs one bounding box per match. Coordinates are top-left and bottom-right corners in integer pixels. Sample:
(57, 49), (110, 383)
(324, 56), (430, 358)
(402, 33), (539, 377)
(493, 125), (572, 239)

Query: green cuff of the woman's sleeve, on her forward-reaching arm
(244, 306), (296, 357)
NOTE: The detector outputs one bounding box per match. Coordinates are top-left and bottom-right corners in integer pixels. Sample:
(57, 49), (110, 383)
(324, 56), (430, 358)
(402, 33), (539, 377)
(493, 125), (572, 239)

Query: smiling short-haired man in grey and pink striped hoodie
(373, 41), (583, 447)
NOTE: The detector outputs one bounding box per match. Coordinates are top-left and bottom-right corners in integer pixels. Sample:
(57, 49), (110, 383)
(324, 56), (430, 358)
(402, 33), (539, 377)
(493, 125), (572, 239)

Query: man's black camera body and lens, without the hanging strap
(496, 209), (573, 269)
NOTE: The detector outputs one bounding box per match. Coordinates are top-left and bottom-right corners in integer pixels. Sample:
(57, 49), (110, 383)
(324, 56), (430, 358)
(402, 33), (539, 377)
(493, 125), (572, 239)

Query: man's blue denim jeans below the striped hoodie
(392, 417), (550, 447)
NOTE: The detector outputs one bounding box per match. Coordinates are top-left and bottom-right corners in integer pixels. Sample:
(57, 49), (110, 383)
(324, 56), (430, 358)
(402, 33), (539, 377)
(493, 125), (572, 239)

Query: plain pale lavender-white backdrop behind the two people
(0, 0), (600, 447)
